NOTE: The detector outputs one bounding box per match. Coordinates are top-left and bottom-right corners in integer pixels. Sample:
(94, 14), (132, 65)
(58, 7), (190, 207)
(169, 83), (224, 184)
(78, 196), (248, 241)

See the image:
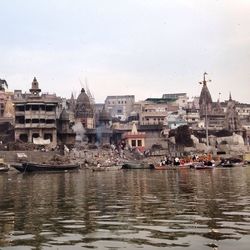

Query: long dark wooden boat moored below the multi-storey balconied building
(12, 162), (80, 173)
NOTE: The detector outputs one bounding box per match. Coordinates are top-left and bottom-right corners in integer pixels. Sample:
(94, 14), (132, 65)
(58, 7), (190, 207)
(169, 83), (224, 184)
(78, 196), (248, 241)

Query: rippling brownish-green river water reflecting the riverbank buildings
(0, 166), (250, 250)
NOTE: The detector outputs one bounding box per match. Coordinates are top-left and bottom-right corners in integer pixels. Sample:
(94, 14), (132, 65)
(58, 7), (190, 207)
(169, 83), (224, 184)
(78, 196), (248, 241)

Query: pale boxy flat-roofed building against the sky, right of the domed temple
(105, 95), (135, 121)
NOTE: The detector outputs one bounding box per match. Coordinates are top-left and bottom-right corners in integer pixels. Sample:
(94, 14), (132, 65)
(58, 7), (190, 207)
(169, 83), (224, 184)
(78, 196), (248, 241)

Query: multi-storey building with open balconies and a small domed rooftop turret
(13, 78), (59, 146)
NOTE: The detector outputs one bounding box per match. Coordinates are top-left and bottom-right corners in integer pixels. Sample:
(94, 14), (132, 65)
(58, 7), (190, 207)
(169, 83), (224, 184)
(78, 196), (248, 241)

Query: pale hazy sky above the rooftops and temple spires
(0, 0), (250, 103)
